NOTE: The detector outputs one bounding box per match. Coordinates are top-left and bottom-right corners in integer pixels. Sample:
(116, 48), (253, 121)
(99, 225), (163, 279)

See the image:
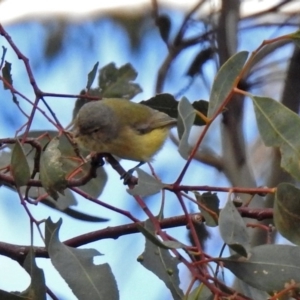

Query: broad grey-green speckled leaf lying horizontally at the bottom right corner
(221, 245), (300, 293)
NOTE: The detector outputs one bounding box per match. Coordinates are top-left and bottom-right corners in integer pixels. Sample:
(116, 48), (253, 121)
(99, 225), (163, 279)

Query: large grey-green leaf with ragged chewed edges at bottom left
(45, 218), (119, 300)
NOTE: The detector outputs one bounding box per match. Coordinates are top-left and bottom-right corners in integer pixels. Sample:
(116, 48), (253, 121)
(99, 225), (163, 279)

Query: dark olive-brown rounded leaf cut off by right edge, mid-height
(273, 183), (300, 245)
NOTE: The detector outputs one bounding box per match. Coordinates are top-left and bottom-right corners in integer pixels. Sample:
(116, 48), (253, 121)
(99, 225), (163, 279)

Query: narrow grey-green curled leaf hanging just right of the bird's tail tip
(177, 97), (196, 159)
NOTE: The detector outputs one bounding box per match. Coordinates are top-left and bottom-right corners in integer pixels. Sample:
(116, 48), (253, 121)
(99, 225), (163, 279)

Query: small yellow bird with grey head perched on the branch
(73, 98), (177, 177)
